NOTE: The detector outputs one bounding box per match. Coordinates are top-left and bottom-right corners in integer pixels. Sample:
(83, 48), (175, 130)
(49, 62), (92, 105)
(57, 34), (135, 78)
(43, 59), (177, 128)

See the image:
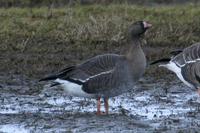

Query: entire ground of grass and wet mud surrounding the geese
(0, 3), (200, 133)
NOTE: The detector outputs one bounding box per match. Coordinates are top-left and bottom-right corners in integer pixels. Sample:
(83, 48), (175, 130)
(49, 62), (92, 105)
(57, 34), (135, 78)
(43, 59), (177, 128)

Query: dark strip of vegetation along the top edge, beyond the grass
(0, 0), (199, 8)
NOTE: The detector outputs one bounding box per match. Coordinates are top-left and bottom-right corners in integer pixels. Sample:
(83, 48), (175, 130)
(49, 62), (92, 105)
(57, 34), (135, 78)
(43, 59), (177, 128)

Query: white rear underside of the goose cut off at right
(160, 61), (193, 88)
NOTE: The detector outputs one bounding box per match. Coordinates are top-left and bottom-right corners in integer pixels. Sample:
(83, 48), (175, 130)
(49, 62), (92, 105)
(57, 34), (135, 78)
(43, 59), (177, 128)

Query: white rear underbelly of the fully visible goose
(55, 79), (95, 98)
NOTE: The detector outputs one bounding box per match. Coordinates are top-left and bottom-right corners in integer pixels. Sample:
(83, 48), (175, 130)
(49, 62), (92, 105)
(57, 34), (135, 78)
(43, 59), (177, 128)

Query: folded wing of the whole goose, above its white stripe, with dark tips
(40, 54), (123, 84)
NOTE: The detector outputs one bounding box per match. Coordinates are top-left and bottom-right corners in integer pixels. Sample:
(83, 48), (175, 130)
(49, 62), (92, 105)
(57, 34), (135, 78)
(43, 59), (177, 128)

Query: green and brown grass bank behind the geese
(0, 4), (200, 77)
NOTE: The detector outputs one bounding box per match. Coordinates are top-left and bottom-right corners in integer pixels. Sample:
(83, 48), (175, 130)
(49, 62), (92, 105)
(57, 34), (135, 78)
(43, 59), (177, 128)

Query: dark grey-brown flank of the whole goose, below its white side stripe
(82, 60), (132, 95)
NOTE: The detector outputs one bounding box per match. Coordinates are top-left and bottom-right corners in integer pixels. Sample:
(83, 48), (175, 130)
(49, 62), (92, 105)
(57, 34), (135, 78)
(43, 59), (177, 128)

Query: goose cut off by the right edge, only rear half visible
(151, 43), (200, 95)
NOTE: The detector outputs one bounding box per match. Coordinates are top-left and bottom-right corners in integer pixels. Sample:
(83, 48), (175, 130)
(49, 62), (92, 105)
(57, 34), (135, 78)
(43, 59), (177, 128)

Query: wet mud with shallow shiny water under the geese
(0, 76), (200, 133)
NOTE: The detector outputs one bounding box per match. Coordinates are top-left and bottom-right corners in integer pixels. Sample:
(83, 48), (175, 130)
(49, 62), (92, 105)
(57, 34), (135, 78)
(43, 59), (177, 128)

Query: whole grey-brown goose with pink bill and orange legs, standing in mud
(40, 21), (151, 114)
